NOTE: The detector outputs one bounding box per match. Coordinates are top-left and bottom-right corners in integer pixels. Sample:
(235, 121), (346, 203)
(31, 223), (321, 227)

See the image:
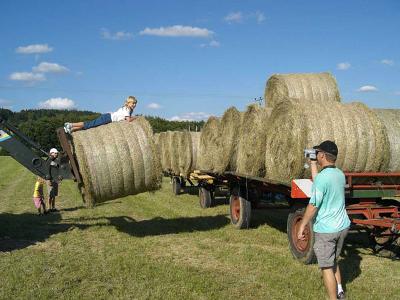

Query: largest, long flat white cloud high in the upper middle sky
(139, 25), (214, 38)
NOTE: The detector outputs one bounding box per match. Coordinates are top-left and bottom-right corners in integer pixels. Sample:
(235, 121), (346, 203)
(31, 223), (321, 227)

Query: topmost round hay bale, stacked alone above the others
(264, 72), (340, 107)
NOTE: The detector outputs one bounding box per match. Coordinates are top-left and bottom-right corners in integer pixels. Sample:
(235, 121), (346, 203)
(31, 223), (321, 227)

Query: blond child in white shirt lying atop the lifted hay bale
(64, 96), (137, 134)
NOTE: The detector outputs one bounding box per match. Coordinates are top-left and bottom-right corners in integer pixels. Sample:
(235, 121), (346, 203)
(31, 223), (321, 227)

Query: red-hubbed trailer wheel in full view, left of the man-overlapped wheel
(229, 192), (251, 229)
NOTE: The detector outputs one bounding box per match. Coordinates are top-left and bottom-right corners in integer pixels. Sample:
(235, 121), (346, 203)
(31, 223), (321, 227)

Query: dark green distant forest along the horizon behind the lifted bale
(0, 108), (204, 155)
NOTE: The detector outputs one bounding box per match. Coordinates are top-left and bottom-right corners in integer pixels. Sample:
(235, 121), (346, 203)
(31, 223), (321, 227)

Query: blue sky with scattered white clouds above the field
(0, 0), (400, 119)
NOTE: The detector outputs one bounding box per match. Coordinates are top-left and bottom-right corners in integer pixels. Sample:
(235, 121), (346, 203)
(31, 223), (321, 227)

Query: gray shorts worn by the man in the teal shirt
(314, 228), (349, 268)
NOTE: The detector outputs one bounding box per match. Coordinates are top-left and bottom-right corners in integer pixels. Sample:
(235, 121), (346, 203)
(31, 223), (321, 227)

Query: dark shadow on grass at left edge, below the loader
(0, 213), (89, 252)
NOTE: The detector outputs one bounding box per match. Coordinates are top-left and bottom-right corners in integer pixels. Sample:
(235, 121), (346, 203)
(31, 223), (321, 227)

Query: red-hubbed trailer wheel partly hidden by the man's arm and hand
(287, 207), (316, 264)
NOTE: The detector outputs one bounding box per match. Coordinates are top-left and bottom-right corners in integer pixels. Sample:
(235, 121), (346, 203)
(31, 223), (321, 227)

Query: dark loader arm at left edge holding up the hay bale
(0, 117), (75, 180)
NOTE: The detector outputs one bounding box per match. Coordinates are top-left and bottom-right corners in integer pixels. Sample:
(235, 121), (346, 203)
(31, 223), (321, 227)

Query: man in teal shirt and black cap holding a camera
(298, 141), (350, 299)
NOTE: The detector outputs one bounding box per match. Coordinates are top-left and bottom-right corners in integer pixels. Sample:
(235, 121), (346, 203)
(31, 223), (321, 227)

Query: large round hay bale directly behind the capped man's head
(265, 100), (389, 183)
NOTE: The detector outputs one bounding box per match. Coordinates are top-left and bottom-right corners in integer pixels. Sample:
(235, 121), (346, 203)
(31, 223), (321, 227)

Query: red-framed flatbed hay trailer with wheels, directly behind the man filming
(191, 171), (400, 264)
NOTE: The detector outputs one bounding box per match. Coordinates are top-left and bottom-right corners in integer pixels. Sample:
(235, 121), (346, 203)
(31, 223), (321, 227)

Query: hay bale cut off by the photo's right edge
(373, 109), (400, 172)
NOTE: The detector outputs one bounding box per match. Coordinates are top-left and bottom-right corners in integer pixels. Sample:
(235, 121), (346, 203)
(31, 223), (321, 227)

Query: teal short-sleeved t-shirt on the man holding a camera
(309, 168), (350, 233)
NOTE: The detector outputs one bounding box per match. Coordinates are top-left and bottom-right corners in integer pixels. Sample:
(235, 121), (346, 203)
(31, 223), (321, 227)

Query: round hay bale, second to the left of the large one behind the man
(214, 107), (242, 173)
